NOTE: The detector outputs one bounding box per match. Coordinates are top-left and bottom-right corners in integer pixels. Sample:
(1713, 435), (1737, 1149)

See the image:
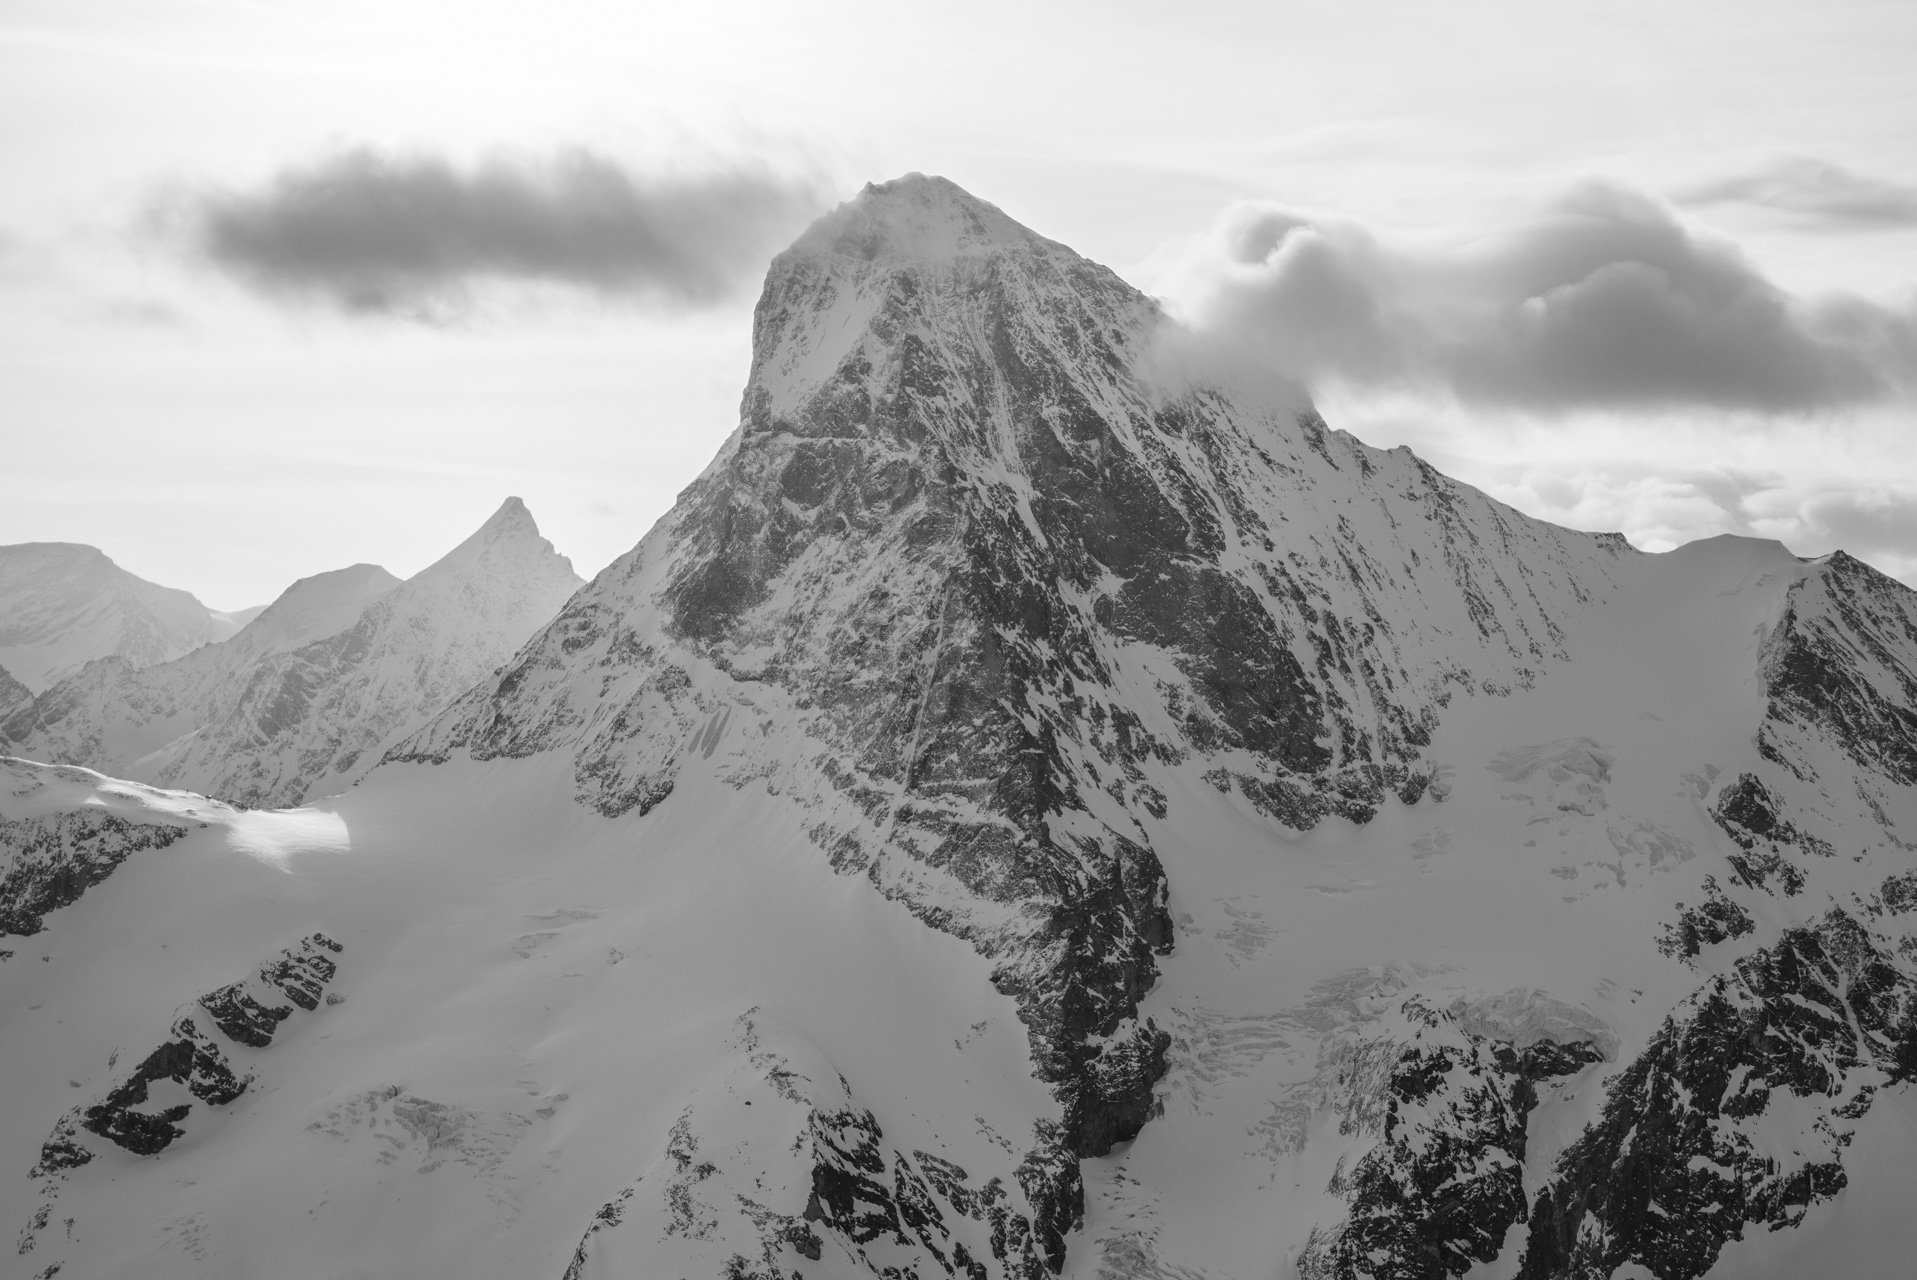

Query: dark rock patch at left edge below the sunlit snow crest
(0, 809), (186, 937)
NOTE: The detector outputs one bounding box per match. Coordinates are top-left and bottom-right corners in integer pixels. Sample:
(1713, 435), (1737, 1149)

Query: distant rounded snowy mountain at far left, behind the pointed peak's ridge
(0, 542), (236, 692)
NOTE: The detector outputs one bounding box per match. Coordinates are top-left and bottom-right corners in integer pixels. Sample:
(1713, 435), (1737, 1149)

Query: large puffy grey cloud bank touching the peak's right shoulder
(1146, 182), (1917, 414)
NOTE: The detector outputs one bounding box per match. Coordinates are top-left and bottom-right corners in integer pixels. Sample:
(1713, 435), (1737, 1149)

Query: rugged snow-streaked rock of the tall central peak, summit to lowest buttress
(387, 178), (1628, 1272)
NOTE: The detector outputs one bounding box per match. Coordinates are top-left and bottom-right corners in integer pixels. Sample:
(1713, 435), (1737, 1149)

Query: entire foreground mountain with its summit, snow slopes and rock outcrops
(0, 176), (1917, 1280)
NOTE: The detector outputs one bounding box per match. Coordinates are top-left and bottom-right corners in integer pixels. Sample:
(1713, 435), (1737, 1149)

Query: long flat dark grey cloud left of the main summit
(161, 149), (822, 318)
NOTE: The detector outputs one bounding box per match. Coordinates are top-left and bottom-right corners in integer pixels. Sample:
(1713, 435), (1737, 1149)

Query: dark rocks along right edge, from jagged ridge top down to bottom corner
(1520, 554), (1917, 1280)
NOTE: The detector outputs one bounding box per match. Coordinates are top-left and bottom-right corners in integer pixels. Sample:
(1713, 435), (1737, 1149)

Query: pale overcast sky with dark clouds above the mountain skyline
(0, 0), (1917, 609)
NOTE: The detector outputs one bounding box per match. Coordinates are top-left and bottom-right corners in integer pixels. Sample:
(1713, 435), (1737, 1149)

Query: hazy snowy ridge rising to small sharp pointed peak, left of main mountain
(0, 498), (579, 807)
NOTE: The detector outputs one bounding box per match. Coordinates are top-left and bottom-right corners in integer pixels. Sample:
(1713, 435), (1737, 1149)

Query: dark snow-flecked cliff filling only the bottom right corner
(1518, 910), (1917, 1280)
